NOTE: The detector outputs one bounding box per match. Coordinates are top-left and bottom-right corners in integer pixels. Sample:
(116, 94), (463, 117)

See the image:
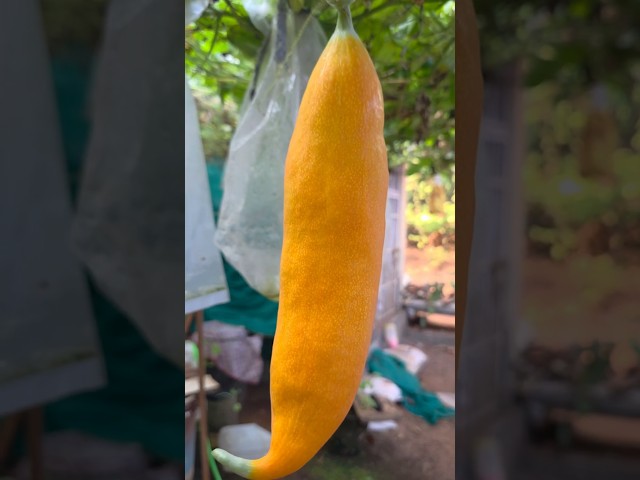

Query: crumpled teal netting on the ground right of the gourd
(367, 349), (455, 425)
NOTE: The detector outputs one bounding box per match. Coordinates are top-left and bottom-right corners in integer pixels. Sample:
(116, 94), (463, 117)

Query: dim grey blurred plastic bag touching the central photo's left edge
(74, 0), (211, 367)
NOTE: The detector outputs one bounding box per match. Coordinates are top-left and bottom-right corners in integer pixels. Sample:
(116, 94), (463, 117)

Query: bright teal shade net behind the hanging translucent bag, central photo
(204, 164), (278, 336)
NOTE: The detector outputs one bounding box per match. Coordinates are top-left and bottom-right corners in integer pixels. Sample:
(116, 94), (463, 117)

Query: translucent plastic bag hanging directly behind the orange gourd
(216, 7), (326, 300)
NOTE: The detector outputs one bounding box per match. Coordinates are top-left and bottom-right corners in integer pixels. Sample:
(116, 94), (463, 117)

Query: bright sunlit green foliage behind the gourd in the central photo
(185, 0), (455, 245)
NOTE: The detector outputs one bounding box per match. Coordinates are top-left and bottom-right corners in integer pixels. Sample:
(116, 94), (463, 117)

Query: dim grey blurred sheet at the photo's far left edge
(0, 0), (106, 417)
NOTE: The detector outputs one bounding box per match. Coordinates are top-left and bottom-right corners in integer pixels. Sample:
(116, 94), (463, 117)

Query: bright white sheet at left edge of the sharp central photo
(184, 77), (229, 313)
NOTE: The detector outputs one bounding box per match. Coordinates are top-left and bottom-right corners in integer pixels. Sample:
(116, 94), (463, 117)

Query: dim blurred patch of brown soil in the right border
(519, 258), (640, 348)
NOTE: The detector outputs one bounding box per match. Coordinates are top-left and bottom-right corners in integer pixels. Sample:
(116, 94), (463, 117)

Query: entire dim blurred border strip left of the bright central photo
(0, 0), (184, 478)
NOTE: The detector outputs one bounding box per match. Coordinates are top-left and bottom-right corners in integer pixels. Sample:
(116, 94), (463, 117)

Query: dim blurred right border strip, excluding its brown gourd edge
(456, 0), (640, 479)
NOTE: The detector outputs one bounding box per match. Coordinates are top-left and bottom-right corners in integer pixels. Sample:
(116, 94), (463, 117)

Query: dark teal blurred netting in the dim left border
(45, 51), (184, 462)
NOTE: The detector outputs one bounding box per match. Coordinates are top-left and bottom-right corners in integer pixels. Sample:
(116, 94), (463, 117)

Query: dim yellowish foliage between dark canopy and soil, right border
(523, 82), (640, 260)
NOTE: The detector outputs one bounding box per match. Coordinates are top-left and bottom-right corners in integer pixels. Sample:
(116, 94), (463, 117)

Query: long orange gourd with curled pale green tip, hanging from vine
(214, 7), (389, 480)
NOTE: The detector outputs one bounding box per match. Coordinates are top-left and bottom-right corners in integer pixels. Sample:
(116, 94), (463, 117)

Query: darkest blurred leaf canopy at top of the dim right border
(474, 0), (640, 96)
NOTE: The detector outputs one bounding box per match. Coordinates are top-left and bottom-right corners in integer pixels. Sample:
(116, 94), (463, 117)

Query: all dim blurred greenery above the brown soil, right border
(475, 0), (640, 260)
